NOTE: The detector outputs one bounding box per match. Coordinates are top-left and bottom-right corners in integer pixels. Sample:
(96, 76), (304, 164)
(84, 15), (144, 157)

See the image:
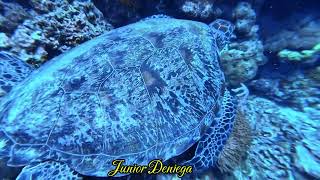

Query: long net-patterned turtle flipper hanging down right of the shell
(185, 90), (236, 171)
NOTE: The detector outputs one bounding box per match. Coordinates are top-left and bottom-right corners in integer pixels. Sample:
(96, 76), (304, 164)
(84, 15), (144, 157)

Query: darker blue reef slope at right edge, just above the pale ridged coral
(249, 68), (320, 111)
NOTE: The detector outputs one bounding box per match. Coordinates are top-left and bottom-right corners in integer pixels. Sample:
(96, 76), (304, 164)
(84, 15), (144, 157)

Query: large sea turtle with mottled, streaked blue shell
(0, 17), (250, 179)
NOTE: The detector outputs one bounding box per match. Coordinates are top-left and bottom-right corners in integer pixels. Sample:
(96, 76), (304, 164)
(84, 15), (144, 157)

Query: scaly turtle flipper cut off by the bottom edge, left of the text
(17, 161), (81, 180)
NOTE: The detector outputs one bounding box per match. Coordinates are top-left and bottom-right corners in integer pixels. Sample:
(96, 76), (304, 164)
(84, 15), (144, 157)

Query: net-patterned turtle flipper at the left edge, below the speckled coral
(0, 52), (34, 98)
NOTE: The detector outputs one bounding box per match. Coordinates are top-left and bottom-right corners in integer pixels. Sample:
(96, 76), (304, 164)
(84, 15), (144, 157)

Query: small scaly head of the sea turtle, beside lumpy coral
(209, 19), (234, 51)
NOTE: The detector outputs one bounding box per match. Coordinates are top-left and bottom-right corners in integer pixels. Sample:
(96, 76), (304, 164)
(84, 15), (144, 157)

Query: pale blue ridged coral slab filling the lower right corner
(234, 96), (320, 179)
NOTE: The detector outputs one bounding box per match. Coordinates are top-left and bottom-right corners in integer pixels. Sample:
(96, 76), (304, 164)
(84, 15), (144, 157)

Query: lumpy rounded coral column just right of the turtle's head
(220, 2), (267, 85)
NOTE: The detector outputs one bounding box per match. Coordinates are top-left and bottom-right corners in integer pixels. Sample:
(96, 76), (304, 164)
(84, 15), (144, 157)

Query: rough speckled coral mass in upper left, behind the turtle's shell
(2, 0), (112, 65)
